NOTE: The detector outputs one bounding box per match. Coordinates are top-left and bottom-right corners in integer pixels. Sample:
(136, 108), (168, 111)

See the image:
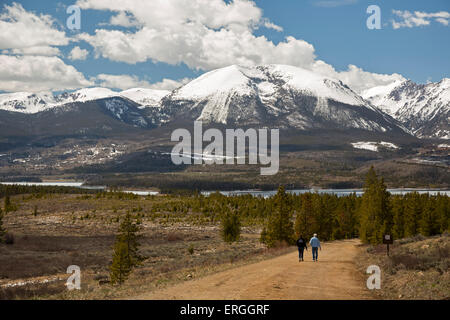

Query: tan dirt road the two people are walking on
(136, 240), (371, 300)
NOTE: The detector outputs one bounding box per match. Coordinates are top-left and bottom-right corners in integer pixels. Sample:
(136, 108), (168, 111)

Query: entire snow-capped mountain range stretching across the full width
(0, 65), (450, 139)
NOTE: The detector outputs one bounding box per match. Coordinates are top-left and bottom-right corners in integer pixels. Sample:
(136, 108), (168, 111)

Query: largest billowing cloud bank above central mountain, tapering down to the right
(77, 0), (401, 91)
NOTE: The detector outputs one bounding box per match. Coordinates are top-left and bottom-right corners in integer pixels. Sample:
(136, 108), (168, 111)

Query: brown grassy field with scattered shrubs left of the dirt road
(0, 194), (292, 299)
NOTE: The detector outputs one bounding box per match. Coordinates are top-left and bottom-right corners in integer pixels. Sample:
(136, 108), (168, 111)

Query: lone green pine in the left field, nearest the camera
(110, 212), (145, 284)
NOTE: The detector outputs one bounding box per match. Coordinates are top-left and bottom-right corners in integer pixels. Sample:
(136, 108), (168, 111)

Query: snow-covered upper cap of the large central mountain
(172, 64), (366, 105)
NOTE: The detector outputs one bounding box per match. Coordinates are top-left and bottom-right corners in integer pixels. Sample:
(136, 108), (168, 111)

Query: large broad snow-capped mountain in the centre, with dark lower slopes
(156, 65), (399, 132)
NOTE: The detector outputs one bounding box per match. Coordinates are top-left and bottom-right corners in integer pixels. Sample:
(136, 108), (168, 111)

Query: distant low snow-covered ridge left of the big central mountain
(0, 88), (169, 114)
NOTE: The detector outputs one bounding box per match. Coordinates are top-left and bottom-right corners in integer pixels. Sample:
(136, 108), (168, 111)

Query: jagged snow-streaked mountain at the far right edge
(361, 78), (450, 139)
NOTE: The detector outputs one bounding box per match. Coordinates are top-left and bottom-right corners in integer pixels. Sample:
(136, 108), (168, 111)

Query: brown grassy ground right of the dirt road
(358, 234), (450, 300)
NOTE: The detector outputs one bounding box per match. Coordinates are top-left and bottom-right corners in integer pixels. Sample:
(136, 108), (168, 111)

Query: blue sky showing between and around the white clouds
(0, 0), (450, 91)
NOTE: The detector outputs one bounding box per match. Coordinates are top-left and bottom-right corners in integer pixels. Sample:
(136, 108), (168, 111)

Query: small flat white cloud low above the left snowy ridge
(95, 74), (191, 90)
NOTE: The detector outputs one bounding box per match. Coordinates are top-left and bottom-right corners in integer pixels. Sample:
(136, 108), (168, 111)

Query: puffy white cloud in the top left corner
(0, 3), (69, 55)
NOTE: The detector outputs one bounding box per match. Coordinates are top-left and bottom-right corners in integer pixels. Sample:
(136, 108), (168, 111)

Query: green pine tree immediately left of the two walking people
(261, 186), (295, 247)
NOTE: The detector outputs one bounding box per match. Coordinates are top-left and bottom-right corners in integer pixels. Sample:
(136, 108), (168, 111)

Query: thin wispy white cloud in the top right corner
(391, 10), (450, 29)
